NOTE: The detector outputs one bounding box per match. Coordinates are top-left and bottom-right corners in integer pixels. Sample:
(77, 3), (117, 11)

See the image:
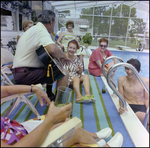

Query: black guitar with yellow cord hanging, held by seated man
(36, 45), (66, 81)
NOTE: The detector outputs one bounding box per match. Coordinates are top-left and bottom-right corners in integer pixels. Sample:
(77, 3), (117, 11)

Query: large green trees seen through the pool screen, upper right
(80, 4), (145, 37)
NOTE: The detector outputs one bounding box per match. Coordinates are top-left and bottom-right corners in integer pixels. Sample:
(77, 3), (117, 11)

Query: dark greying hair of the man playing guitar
(38, 10), (55, 24)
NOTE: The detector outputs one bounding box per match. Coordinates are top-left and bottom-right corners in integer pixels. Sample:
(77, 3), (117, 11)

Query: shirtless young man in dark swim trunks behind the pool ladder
(118, 59), (149, 123)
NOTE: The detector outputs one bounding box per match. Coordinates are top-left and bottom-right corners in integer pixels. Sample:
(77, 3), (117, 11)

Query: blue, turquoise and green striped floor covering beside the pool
(1, 70), (135, 147)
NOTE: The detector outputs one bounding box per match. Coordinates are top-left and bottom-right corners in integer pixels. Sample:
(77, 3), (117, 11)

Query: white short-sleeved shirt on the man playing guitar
(13, 22), (55, 68)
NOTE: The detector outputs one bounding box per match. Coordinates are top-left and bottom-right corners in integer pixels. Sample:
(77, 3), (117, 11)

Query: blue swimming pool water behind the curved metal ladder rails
(108, 50), (149, 85)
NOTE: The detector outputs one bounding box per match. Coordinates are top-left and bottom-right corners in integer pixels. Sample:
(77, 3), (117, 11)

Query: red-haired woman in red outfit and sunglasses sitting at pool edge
(88, 38), (117, 80)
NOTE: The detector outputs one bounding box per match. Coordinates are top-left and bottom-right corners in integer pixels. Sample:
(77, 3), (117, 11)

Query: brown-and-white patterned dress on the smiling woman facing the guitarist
(63, 55), (83, 86)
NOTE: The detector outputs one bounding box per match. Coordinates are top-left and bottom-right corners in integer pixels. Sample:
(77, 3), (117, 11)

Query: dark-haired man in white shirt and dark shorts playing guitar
(13, 10), (71, 100)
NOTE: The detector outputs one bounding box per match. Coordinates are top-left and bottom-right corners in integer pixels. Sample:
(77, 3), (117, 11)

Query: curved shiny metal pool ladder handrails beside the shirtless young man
(102, 56), (149, 128)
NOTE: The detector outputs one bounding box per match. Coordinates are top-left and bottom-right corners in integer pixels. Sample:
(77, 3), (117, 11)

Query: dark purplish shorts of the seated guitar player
(12, 67), (53, 85)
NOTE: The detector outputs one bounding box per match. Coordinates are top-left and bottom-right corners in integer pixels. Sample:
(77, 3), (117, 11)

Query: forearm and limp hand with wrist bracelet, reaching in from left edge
(1, 85), (50, 106)
